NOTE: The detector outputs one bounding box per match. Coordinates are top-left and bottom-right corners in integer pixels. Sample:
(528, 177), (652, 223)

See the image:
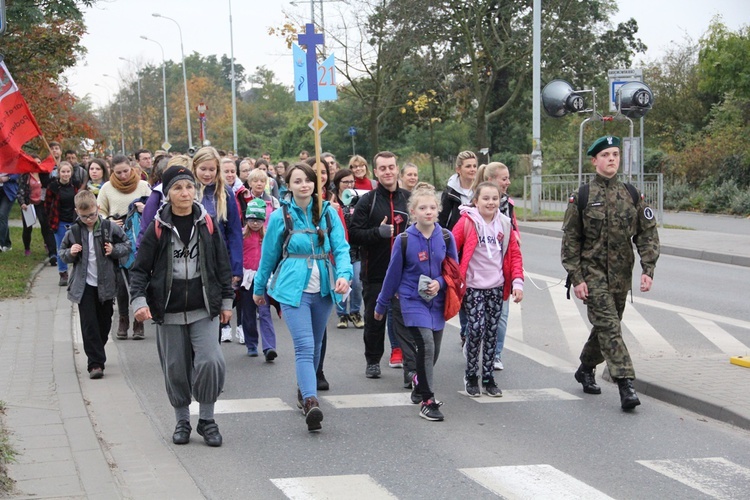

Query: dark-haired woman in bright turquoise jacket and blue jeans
(253, 164), (352, 431)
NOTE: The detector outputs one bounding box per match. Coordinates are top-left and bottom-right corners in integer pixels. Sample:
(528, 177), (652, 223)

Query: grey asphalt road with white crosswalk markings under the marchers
(120, 235), (750, 499)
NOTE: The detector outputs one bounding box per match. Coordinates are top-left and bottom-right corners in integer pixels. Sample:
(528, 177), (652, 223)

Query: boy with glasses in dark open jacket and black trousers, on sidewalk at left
(58, 190), (130, 379)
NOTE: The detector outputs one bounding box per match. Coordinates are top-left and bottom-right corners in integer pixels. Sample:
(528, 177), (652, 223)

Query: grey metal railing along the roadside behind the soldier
(516, 173), (664, 225)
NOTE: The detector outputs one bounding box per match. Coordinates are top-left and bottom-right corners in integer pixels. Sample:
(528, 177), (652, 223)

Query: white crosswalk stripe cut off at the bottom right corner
(636, 457), (750, 499)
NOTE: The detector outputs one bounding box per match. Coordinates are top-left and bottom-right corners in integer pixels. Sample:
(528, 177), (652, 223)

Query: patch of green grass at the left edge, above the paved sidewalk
(0, 226), (47, 300)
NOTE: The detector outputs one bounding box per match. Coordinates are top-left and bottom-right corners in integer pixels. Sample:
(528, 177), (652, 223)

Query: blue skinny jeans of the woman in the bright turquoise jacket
(281, 292), (333, 399)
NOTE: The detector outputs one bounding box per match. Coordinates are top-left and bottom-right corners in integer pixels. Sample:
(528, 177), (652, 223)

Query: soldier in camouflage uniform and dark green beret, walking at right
(562, 136), (659, 410)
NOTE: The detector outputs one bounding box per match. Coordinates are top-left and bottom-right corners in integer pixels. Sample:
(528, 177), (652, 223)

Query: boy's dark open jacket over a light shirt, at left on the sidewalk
(58, 216), (130, 304)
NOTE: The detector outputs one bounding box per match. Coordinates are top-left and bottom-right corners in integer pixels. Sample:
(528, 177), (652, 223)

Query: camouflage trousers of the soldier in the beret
(579, 289), (635, 379)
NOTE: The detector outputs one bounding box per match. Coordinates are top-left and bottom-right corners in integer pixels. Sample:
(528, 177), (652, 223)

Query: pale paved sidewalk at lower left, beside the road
(0, 266), (203, 499)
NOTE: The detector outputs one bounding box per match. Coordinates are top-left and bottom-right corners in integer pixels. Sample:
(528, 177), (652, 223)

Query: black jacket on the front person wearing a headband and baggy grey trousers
(130, 203), (234, 323)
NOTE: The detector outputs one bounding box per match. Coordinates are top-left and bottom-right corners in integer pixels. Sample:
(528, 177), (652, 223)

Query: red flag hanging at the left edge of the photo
(0, 61), (54, 174)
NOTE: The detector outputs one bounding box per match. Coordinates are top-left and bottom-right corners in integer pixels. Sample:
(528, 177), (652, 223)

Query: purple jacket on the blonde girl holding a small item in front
(375, 224), (458, 330)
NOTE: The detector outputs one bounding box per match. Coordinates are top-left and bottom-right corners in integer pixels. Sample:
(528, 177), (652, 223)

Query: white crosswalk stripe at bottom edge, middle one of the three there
(459, 464), (611, 500)
